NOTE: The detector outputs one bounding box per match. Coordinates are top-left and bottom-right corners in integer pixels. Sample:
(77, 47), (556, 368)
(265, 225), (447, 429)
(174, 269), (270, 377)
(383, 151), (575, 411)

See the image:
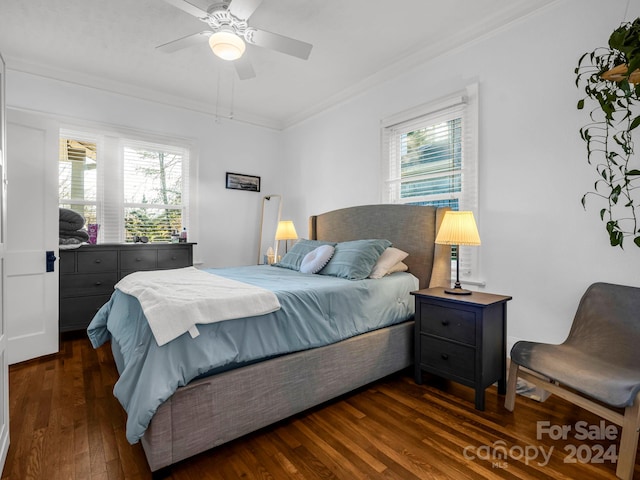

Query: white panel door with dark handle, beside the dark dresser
(4, 110), (59, 364)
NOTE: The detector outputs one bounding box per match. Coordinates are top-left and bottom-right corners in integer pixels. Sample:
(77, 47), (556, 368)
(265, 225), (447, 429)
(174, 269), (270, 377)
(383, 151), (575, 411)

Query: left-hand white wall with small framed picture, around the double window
(6, 71), (282, 266)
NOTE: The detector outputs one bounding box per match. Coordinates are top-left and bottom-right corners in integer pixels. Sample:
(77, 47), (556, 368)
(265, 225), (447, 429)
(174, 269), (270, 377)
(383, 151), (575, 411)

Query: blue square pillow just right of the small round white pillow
(320, 239), (391, 280)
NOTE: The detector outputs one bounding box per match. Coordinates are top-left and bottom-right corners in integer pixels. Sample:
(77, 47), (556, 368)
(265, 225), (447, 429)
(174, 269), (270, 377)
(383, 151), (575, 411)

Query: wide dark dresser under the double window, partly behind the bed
(59, 243), (194, 332)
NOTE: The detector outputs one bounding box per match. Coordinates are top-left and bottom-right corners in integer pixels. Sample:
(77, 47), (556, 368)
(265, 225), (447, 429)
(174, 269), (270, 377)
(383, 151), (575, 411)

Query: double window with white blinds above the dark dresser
(58, 131), (189, 243)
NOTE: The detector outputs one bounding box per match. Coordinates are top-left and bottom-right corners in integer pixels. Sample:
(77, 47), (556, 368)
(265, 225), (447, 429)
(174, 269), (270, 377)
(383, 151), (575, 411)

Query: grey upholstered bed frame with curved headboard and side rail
(138, 205), (451, 472)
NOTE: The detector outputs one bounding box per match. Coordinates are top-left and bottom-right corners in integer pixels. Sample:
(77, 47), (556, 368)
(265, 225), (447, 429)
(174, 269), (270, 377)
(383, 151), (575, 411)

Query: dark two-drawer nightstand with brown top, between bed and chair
(412, 287), (511, 410)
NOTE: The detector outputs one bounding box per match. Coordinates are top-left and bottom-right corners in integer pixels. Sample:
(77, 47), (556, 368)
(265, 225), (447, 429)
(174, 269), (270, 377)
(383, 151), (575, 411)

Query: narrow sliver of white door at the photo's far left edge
(0, 51), (9, 472)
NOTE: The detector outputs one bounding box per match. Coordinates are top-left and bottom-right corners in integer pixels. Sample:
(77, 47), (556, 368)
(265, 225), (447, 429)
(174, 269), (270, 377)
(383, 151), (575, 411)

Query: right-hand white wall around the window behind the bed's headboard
(284, 0), (640, 350)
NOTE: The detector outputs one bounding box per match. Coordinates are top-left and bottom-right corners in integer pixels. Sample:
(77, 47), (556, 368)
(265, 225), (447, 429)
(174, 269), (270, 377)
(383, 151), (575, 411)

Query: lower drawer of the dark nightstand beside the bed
(420, 335), (475, 382)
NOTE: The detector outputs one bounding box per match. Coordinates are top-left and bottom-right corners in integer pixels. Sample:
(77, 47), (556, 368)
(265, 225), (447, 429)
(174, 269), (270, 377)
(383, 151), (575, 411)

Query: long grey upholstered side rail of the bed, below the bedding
(141, 321), (413, 471)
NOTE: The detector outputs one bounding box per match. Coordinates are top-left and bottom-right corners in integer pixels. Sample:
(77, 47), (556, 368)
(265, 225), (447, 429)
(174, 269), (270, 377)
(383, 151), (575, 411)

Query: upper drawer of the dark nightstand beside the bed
(420, 304), (476, 345)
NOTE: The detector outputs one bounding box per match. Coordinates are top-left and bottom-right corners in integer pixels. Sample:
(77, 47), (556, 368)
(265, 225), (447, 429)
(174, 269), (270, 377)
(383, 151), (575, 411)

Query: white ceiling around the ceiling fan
(0, 0), (557, 128)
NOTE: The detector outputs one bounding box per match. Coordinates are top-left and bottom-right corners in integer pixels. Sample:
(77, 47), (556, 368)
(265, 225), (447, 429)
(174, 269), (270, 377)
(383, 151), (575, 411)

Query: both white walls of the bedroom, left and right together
(7, 0), (640, 350)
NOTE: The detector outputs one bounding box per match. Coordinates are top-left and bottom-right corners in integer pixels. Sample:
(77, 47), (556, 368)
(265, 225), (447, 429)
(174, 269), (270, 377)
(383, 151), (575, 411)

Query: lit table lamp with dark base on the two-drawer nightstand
(436, 210), (480, 295)
